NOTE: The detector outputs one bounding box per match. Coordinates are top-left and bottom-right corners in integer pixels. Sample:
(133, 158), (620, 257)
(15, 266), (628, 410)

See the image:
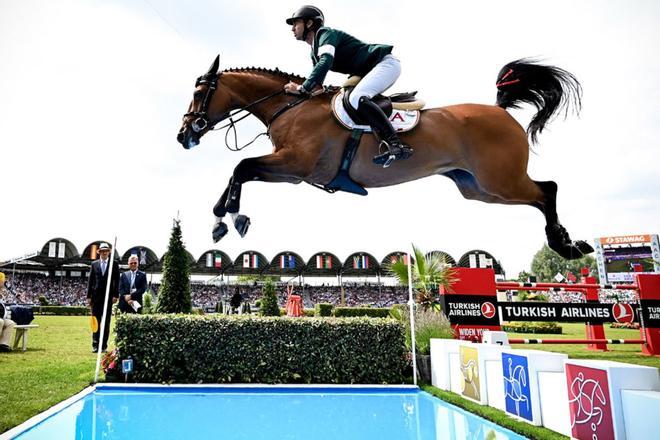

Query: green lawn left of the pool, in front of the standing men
(0, 316), (113, 432)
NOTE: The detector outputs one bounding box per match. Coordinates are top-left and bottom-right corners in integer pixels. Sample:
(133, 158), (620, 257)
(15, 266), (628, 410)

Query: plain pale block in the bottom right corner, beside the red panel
(621, 390), (660, 440)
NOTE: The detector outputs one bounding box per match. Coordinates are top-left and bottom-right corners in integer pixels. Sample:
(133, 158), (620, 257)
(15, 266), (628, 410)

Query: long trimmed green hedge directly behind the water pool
(115, 314), (406, 383)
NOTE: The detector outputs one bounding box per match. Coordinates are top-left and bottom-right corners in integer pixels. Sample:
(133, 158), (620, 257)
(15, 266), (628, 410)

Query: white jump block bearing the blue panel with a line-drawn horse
(500, 349), (568, 426)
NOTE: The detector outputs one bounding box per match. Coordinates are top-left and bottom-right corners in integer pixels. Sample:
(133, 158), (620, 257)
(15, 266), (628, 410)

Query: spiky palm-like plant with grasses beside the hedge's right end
(388, 245), (456, 383)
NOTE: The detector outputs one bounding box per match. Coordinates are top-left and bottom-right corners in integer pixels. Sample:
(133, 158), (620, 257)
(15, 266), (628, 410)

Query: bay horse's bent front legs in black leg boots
(213, 152), (300, 242)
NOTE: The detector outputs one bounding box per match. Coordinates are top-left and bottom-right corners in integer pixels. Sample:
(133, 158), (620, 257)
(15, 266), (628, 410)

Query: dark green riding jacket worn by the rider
(303, 27), (392, 92)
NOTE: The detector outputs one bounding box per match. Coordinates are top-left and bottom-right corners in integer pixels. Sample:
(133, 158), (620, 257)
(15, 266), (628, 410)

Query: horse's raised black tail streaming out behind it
(496, 58), (582, 144)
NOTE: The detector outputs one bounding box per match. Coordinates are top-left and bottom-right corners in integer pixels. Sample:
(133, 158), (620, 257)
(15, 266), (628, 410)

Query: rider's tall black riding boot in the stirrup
(357, 96), (413, 168)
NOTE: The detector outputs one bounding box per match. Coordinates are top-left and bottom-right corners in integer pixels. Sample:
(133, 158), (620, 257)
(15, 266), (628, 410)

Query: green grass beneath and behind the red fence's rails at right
(507, 323), (660, 368)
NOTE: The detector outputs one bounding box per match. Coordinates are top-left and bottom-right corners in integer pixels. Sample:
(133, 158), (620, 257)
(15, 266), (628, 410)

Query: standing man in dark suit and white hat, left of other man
(87, 243), (119, 352)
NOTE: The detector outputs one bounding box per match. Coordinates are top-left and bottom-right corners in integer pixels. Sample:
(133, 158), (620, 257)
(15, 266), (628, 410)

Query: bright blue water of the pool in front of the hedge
(16, 387), (524, 440)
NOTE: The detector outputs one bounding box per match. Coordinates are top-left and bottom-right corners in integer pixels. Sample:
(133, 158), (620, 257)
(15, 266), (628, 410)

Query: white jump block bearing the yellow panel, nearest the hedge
(450, 341), (504, 408)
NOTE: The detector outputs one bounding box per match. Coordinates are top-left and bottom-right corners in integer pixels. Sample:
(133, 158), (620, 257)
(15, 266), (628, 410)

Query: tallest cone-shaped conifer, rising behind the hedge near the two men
(156, 220), (192, 313)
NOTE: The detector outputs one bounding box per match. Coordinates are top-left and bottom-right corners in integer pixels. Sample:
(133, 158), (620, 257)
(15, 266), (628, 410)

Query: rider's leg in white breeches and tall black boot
(349, 55), (412, 168)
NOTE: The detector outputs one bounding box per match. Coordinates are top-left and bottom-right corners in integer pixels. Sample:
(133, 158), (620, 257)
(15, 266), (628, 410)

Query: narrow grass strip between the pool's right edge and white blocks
(420, 384), (568, 440)
